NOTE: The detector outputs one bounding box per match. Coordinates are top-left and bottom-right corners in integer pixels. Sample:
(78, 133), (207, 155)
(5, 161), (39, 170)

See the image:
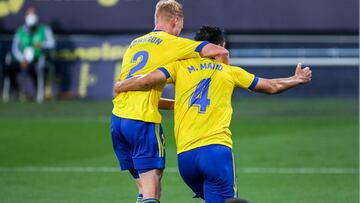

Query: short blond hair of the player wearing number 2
(155, 0), (184, 23)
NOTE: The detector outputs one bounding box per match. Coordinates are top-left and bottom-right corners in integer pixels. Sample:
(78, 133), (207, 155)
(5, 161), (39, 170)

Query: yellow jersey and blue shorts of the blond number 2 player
(111, 30), (208, 178)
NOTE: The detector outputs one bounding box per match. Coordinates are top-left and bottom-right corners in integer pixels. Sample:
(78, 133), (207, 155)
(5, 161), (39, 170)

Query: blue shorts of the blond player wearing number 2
(111, 115), (165, 178)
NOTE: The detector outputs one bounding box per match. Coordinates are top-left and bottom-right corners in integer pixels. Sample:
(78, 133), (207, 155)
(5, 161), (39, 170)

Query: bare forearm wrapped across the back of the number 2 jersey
(113, 70), (167, 96)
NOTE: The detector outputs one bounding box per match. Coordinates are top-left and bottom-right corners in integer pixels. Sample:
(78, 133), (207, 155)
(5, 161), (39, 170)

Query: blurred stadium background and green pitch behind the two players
(0, 0), (359, 203)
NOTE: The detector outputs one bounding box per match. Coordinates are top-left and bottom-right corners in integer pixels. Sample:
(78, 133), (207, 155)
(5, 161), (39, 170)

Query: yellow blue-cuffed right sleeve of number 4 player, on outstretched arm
(230, 66), (259, 90)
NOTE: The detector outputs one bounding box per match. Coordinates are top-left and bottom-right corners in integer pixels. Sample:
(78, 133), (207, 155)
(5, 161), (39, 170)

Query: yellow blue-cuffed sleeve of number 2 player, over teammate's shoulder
(172, 37), (209, 60)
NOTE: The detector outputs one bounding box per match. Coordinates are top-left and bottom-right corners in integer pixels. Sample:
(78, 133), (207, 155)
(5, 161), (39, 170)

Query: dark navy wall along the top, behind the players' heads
(0, 0), (359, 32)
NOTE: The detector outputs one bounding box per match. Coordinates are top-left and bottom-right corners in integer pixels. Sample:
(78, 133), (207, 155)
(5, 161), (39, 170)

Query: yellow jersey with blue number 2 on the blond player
(112, 30), (208, 123)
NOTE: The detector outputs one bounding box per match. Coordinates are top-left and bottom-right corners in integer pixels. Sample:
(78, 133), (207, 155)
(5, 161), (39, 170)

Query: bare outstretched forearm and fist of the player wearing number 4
(253, 63), (312, 94)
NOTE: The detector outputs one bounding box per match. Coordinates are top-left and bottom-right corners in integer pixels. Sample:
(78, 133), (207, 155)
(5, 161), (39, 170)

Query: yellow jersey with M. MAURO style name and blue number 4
(159, 58), (258, 154)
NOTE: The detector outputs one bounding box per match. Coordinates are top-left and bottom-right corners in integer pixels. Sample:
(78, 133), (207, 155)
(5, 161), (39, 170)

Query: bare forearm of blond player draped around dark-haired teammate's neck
(200, 43), (229, 64)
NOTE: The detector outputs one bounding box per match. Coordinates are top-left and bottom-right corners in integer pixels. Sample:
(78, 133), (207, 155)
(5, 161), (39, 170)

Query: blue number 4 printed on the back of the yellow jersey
(189, 78), (211, 113)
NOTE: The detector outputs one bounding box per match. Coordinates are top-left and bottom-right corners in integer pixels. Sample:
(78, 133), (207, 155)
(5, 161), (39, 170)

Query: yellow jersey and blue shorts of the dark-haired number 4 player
(159, 58), (259, 203)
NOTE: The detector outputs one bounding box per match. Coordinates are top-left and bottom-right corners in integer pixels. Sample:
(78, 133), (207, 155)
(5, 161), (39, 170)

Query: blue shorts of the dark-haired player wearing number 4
(178, 145), (237, 203)
